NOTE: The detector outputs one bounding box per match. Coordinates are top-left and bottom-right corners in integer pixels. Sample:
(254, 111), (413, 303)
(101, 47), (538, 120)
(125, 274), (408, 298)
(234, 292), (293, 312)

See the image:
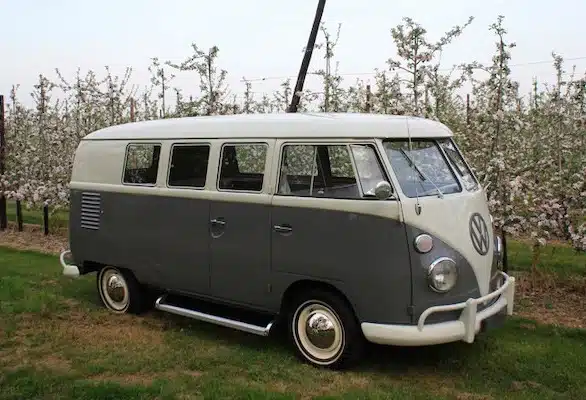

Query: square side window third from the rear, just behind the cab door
(218, 144), (267, 192)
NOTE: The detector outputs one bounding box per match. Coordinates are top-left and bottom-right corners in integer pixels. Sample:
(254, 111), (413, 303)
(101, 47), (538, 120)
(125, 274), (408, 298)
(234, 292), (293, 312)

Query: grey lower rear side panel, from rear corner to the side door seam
(70, 190), (210, 294)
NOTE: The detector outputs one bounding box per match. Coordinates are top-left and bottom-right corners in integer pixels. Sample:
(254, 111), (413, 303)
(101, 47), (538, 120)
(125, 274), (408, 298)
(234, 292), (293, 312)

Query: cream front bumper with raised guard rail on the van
(361, 271), (515, 346)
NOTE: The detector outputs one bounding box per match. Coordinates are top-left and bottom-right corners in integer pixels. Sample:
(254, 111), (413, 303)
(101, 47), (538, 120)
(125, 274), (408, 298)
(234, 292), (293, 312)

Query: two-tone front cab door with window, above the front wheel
(271, 142), (411, 323)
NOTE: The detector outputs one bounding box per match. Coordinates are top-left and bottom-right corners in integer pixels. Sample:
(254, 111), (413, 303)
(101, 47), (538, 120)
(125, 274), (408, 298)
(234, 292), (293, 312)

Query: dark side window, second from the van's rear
(168, 144), (210, 188)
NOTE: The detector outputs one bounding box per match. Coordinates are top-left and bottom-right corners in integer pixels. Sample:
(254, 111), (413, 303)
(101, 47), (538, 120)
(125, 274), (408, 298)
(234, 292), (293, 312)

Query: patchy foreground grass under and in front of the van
(0, 247), (586, 400)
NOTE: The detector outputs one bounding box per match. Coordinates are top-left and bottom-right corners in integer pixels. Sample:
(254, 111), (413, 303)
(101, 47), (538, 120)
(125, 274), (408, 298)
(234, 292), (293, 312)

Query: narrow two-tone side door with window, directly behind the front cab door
(209, 143), (271, 308)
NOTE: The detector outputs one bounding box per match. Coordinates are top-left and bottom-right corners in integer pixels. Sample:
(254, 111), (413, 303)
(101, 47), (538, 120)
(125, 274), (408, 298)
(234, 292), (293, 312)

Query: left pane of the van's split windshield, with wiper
(383, 139), (462, 197)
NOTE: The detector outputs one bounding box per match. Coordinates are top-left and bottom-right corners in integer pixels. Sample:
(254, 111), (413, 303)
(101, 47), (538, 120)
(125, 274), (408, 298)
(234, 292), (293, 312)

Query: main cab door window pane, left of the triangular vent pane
(277, 145), (362, 199)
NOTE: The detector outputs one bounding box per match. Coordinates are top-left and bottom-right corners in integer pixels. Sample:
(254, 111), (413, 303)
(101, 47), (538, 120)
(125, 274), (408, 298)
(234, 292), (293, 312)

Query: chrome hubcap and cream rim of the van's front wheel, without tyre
(294, 301), (344, 365)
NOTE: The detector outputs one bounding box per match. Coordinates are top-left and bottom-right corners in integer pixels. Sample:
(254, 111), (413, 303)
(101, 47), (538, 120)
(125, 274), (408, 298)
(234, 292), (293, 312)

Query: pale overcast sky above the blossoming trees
(0, 0), (586, 107)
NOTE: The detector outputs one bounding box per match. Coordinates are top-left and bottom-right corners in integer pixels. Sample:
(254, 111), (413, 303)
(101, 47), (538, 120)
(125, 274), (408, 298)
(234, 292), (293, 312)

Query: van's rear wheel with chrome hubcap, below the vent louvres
(96, 267), (148, 314)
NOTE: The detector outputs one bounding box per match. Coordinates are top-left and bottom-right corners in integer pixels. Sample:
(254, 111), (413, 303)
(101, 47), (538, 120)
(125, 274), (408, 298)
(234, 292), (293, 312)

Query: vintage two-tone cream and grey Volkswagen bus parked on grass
(61, 114), (514, 368)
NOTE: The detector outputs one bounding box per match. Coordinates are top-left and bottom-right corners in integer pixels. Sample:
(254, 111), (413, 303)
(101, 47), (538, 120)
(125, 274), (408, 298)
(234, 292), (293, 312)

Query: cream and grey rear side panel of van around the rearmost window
(70, 140), (213, 294)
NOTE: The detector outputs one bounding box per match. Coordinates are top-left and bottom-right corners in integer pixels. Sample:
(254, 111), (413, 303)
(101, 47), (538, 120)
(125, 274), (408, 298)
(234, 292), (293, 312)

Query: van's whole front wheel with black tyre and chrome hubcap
(287, 289), (364, 369)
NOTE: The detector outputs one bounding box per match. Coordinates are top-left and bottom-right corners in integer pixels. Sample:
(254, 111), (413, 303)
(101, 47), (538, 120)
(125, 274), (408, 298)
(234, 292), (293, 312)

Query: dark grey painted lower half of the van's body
(70, 190), (492, 324)
